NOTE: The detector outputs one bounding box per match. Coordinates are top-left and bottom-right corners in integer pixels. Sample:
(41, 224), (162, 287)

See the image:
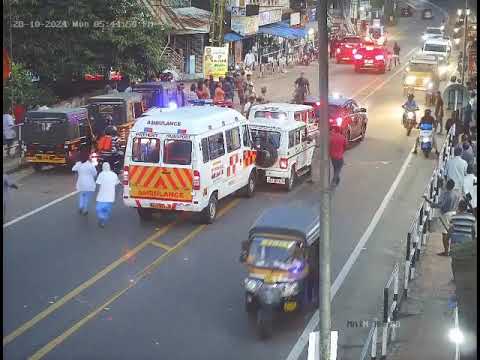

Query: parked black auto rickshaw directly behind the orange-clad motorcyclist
(87, 92), (145, 146)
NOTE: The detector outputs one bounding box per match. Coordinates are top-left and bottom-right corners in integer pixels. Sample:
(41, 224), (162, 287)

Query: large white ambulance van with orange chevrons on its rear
(123, 106), (257, 223)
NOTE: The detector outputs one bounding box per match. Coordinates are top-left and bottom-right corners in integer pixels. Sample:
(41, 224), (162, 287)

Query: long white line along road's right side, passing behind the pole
(287, 152), (413, 360)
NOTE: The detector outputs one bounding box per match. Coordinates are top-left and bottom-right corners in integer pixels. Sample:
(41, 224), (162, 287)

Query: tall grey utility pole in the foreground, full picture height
(317, 0), (331, 360)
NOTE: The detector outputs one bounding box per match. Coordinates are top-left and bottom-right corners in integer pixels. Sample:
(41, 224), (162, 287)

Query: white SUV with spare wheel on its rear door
(249, 119), (315, 191)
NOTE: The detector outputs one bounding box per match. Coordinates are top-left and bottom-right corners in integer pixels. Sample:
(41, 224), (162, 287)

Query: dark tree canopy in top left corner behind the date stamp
(3, 0), (166, 81)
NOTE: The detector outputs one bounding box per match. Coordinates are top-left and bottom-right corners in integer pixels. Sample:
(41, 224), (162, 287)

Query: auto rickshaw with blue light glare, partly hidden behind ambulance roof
(132, 81), (187, 109)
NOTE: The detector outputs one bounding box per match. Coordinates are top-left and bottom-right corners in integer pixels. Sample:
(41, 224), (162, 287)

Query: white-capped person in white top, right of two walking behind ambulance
(96, 162), (120, 227)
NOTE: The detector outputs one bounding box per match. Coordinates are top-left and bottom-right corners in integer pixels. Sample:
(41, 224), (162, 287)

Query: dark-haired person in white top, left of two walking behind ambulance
(72, 149), (97, 215)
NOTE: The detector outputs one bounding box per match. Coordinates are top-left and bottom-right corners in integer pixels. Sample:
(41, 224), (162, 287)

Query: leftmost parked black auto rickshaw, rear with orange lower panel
(23, 107), (92, 171)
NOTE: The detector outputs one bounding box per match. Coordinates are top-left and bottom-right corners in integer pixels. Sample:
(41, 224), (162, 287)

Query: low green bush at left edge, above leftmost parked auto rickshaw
(3, 63), (57, 109)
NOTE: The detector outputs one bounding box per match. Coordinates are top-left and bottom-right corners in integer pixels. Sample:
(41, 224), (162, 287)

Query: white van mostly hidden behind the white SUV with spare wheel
(248, 103), (318, 134)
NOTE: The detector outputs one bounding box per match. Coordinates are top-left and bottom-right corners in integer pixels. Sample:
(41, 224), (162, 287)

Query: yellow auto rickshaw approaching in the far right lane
(403, 55), (440, 106)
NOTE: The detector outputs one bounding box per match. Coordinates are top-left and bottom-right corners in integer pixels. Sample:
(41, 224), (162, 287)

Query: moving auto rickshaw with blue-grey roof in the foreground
(240, 206), (320, 338)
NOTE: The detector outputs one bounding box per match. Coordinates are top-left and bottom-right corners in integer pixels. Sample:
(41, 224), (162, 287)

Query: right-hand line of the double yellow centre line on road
(28, 199), (240, 360)
